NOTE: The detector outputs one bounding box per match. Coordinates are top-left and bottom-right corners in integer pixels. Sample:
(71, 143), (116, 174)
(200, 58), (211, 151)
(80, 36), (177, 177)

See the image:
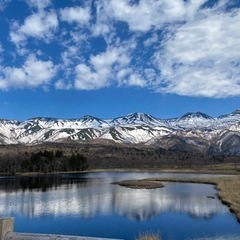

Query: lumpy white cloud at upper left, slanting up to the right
(10, 11), (58, 47)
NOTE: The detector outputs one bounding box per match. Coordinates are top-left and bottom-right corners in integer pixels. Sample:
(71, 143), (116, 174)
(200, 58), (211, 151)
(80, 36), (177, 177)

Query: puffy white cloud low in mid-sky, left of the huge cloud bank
(75, 43), (148, 90)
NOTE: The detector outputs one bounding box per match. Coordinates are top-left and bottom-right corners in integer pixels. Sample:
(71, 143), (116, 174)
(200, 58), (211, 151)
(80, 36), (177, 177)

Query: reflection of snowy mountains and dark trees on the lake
(0, 175), (227, 221)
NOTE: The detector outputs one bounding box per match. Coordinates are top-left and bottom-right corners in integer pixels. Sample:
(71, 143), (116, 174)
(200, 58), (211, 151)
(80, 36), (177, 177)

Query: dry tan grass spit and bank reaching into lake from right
(114, 175), (240, 222)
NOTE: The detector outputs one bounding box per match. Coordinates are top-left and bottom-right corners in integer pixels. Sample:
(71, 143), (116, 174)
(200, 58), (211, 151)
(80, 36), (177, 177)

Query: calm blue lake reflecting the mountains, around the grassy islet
(0, 172), (240, 240)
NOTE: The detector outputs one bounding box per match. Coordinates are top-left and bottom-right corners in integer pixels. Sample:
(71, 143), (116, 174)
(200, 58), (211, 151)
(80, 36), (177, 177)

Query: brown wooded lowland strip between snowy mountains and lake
(0, 143), (240, 175)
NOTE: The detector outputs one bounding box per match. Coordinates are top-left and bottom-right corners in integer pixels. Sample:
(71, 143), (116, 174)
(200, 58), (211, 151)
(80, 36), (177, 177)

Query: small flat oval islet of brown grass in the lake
(113, 179), (164, 189)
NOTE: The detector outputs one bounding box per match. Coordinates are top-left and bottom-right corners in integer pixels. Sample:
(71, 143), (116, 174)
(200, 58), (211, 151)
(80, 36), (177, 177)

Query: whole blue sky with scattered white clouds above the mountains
(0, 0), (240, 120)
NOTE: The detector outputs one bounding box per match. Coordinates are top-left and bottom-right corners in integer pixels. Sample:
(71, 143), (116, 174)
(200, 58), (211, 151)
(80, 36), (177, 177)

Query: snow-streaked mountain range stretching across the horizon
(0, 109), (240, 155)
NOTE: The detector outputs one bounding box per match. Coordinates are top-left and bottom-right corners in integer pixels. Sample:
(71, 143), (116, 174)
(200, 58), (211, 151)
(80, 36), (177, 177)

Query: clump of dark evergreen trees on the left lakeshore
(0, 150), (88, 174)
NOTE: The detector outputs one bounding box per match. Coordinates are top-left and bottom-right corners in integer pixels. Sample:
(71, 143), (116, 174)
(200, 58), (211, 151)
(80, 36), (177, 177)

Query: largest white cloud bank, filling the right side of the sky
(156, 10), (240, 97)
